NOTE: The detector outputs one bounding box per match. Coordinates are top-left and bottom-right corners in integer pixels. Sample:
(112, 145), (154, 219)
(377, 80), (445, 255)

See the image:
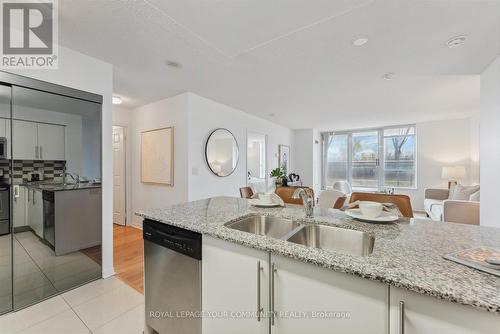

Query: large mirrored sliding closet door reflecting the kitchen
(10, 86), (102, 310)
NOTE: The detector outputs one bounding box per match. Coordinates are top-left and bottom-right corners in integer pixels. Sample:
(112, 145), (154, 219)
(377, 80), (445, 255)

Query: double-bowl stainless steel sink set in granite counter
(225, 215), (375, 256)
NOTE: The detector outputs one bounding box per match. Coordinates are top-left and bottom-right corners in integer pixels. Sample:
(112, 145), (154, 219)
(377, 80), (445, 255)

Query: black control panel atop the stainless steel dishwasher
(143, 219), (201, 260)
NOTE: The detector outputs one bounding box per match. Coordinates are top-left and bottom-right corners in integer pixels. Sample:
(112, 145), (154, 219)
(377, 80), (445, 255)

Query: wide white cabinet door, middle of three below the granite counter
(271, 255), (389, 334)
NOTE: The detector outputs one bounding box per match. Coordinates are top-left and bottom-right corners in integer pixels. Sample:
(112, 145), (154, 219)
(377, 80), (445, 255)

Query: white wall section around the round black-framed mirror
(187, 93), (295, 201)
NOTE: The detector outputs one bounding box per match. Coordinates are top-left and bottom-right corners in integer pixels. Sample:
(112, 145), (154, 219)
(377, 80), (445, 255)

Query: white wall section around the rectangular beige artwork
(129, 94), (188, 226)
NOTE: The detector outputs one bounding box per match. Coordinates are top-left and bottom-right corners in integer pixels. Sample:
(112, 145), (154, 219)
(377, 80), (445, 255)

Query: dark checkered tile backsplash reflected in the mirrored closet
(0, 160), (66, 183)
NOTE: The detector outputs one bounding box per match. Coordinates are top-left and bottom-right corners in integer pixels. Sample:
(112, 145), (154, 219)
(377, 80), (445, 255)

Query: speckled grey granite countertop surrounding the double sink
(136, 197), (500, 313)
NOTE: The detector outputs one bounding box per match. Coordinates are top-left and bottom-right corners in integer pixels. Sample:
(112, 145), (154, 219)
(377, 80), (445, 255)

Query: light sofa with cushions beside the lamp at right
(424, 186), (480, 225)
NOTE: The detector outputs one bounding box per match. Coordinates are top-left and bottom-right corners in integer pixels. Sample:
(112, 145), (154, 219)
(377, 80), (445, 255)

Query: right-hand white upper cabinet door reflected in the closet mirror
(38, 123), (66, 160)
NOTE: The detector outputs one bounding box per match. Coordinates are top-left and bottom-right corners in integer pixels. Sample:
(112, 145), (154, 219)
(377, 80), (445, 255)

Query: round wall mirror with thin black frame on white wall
(205, 129), (239, 177)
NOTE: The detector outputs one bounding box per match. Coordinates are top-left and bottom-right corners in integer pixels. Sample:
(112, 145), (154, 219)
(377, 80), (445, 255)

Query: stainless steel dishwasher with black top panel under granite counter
(143, 219), (201, 334)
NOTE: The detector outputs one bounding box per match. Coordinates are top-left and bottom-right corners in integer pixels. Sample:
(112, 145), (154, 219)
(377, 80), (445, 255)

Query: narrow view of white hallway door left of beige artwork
(113, 126), (126, 225)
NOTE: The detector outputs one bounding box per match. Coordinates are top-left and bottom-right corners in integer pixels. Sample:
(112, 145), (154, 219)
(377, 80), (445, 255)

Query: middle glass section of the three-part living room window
(351, 131), (380, 188)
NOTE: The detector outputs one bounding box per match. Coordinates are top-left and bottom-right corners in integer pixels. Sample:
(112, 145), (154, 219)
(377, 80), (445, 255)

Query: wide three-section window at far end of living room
(323, 125), (417, 189)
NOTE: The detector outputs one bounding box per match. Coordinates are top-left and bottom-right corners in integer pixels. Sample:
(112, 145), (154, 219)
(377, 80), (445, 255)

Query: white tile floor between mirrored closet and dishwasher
(0, 277), (144, 334)
